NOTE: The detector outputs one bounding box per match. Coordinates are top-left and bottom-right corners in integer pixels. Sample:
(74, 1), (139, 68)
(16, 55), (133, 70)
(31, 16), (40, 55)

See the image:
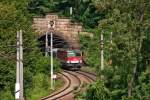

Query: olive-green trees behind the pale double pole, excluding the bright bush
(0, 0), (49, 100)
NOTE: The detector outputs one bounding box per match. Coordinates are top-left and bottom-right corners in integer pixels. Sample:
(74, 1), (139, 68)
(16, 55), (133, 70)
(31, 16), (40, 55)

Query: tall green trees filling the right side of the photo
(79, 0), (150, 100)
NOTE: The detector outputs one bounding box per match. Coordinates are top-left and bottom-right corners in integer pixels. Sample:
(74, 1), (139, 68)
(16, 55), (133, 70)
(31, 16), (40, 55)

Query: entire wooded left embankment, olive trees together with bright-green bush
(0, 0), (62, 100)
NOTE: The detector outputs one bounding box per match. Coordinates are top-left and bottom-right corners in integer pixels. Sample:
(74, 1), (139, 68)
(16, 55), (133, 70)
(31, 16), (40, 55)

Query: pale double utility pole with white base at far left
(15, 30), (24, 100)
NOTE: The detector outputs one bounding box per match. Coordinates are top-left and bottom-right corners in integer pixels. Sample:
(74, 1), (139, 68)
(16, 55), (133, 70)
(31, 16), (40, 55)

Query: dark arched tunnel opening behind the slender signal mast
(38, 34), (69, 54)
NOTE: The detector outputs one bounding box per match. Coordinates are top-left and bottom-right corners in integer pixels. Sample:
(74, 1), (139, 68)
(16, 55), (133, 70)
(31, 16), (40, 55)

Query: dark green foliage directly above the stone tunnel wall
(28, 0), (104, 28)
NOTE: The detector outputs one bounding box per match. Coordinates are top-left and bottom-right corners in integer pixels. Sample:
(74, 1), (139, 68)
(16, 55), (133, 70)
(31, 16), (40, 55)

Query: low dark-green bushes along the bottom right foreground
(80, 69), (150, 100)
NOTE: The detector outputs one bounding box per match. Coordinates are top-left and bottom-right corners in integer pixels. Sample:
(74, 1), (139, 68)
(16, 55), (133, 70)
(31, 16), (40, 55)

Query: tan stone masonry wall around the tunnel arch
(33, 14), (90, 48)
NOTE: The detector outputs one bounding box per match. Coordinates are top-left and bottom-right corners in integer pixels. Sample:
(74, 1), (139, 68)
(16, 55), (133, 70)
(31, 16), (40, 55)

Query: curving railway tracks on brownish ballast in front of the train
(41, 70), (96, 100)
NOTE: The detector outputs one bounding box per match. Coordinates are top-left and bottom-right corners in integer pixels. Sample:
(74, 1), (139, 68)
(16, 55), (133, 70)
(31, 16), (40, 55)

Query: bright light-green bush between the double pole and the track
(26, 73), (50, 100)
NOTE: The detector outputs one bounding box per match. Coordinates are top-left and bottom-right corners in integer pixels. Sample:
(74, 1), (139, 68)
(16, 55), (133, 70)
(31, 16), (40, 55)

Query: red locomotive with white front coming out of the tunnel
(57, 49), (83, 70)
